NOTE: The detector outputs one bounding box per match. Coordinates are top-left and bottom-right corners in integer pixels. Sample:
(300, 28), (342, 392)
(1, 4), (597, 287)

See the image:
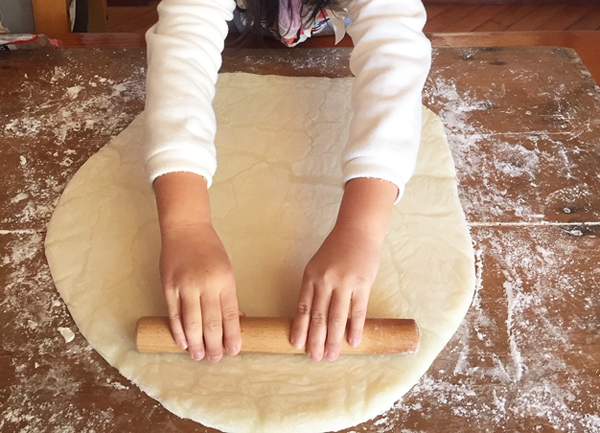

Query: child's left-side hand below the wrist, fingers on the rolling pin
(160, 223), (241, 361)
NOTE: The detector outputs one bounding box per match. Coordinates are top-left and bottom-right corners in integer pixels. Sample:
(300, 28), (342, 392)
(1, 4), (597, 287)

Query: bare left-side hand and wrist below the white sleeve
(154, 173), (242, 361)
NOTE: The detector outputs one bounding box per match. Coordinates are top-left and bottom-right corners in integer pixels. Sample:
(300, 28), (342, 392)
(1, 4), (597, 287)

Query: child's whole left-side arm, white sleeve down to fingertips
(145, 0), (241, 360)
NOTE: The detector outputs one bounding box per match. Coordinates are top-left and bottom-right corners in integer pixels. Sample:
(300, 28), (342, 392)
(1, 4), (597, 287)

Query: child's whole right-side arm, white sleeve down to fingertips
(291, 0), (431, 360)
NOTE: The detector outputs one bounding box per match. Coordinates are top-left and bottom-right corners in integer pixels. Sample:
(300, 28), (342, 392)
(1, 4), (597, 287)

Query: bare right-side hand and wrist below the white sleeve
(290, 178), (398, 361)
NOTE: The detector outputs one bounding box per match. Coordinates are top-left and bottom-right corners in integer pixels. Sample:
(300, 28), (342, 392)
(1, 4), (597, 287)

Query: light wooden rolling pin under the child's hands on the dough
(135, 317), (420, 355)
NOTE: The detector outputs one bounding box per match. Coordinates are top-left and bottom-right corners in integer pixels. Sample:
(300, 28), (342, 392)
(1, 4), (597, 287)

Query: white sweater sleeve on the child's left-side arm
(145, 0), (235, 186)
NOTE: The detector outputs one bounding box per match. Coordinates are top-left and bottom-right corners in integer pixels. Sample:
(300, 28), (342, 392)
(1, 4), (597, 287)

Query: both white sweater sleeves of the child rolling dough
(145, 0), (431, 199)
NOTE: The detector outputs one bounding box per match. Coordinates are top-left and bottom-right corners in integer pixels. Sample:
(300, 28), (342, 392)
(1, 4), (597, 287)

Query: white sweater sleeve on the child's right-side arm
(342, 0), (431, 202)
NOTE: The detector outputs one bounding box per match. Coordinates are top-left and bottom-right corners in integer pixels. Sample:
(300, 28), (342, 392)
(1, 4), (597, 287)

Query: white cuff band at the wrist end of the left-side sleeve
(146, 149), (216, 188)
